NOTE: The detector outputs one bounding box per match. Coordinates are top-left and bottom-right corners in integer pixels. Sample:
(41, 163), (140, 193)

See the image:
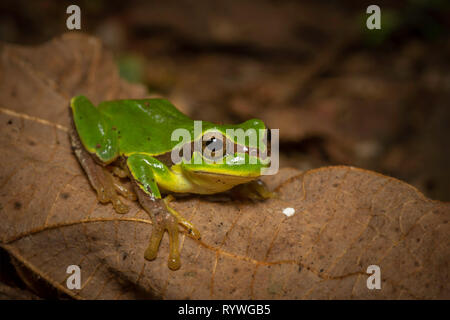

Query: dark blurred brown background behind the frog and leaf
(0, 0), (450, 201)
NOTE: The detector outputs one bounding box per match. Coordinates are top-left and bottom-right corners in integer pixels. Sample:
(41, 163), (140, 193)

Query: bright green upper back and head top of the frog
(71, 96), (265, 162)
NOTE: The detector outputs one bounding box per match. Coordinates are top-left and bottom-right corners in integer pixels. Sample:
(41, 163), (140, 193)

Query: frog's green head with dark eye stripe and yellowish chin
(181, 119), (270, 192)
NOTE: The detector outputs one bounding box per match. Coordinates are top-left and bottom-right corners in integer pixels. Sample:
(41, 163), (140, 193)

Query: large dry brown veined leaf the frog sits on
(0, 34), (450, 299)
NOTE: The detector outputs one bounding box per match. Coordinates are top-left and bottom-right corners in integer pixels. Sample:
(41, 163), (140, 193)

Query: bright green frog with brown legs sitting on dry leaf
(69, 95), (275, 270)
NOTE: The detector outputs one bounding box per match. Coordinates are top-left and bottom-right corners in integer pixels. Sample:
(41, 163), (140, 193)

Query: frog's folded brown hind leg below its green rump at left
(70, 129), (129, 213)
